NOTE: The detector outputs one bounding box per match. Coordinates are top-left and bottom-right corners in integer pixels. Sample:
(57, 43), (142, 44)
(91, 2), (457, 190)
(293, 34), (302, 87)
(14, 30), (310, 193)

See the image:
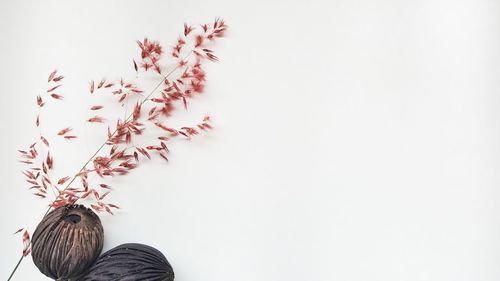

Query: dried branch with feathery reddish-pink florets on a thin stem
(9, 19), (227, 280)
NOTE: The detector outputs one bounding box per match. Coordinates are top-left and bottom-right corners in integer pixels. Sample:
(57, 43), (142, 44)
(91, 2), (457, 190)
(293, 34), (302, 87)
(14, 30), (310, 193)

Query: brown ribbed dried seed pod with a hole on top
(31, 205), (104, 280)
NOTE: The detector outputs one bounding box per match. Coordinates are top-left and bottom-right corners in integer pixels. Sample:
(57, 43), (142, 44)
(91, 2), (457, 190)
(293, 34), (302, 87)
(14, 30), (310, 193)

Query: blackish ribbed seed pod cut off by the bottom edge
(78, 243), (174, 281)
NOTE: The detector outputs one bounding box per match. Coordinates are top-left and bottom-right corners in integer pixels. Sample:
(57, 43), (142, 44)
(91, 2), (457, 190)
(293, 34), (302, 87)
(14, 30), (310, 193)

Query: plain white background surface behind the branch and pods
(0, 0), (500, 281)
